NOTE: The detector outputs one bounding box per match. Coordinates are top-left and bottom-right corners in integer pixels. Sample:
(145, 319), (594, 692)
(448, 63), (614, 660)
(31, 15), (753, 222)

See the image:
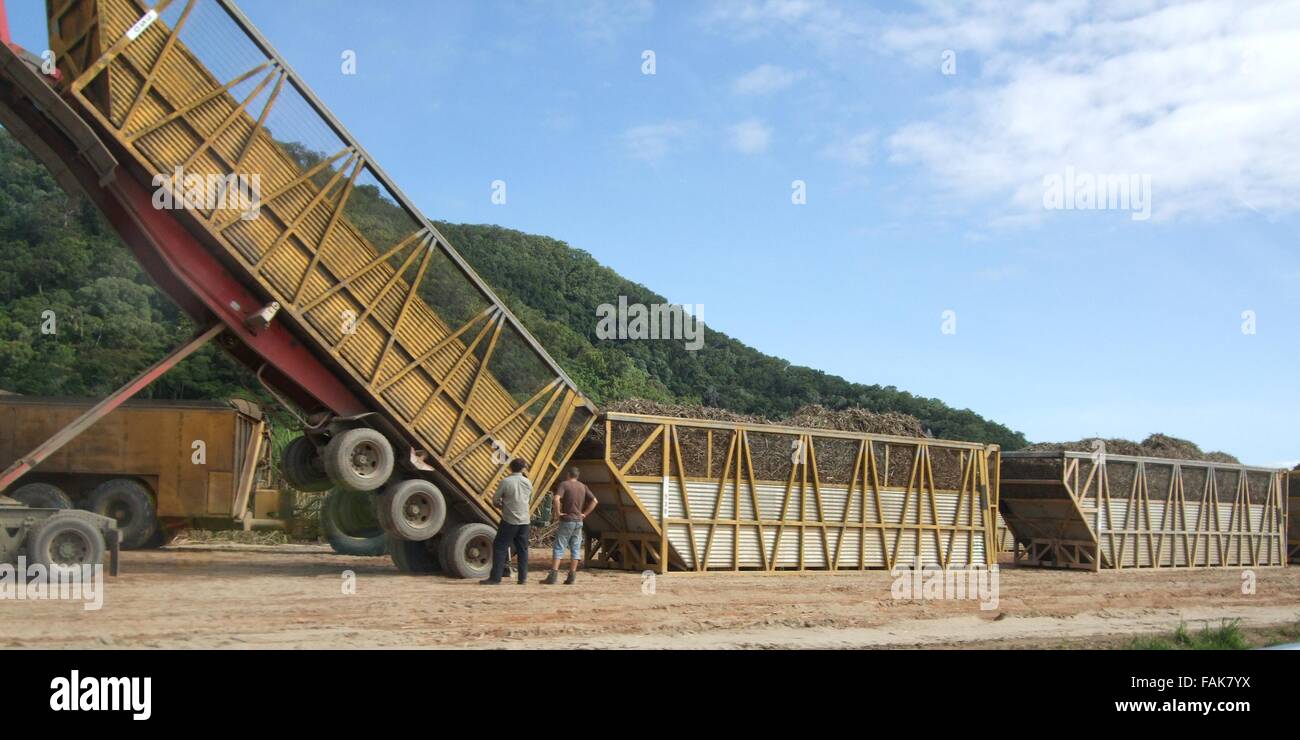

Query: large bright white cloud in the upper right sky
(883, 1), (1300, 218)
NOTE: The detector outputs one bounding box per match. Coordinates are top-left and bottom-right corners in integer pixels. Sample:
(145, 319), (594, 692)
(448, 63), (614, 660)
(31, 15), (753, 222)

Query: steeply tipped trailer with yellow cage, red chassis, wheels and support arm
(0, 0), (595, 577)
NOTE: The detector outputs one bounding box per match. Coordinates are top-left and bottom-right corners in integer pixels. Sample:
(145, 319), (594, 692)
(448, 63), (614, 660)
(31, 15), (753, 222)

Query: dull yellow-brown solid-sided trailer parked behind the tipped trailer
(0, 395), (294, 549)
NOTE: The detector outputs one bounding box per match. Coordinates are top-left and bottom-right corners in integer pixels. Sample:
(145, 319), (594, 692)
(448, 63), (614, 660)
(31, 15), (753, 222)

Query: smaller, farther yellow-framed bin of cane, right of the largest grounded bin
(1000, 451), (1287, 571)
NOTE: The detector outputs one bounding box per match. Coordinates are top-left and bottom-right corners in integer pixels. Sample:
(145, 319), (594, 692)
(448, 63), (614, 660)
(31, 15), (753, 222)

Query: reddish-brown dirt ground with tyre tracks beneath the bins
(0, 545), (1300, 648)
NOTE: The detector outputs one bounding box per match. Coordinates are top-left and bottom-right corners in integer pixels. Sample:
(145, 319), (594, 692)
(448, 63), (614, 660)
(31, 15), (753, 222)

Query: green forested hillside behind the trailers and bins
(0, 130), (1024, 449)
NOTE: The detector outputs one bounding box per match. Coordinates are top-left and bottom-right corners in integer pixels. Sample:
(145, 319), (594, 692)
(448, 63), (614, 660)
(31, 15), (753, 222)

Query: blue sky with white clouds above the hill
(9, 0), (1300, 464)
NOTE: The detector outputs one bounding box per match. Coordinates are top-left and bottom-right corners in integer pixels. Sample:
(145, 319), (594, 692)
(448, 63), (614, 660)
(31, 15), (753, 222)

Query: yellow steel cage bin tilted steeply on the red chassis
(47, 0), (595, 520)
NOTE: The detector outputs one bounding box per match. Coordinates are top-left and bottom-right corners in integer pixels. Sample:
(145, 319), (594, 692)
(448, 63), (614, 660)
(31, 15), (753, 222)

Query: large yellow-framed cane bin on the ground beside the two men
(573, 412), (998, 572)
